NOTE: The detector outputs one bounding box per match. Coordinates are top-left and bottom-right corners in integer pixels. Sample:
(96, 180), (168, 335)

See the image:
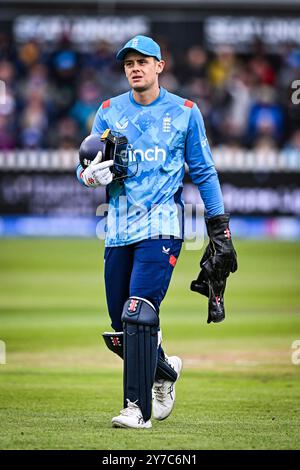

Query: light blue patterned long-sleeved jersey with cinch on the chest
(78, 88), (224, 246)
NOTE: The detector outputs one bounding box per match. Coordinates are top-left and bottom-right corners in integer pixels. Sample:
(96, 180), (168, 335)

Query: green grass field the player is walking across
(0, 239), (300, 450)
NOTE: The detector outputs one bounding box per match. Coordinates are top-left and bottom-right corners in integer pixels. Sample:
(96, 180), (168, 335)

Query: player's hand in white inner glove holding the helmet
(82, 151), (114, 188)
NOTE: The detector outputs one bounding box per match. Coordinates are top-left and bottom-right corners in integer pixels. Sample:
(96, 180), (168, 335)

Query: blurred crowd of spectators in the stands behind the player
(0, 32), (300, 150)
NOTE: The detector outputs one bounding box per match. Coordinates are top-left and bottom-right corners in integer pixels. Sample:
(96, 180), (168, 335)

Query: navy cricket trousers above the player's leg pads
(104, 238), (182, 331)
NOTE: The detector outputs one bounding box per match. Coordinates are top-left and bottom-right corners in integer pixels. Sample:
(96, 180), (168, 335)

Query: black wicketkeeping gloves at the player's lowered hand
(191, 214), (237, 323)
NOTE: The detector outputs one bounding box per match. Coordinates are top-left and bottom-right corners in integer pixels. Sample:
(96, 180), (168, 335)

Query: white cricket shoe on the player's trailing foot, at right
(152, 356), (182, 420)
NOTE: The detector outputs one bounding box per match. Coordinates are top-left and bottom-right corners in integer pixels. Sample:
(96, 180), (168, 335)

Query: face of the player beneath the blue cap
(124, 52), (165, 92)
